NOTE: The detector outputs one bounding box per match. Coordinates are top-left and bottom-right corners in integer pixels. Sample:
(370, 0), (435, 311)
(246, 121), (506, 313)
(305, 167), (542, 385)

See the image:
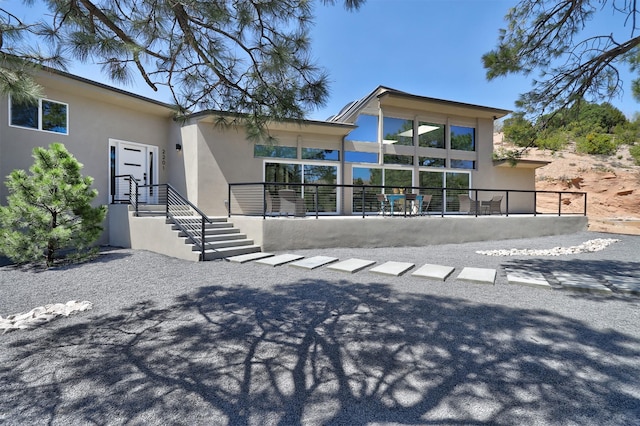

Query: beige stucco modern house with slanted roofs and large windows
(0, 70), (586, 260)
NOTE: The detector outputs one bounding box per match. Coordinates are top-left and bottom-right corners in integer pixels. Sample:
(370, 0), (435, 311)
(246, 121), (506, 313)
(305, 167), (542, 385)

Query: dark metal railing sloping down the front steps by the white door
(111, 175), (213, 260)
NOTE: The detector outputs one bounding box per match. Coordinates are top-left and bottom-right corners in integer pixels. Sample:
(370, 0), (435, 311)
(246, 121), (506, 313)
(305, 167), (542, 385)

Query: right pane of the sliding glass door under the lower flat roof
(304, 164), (338, 213)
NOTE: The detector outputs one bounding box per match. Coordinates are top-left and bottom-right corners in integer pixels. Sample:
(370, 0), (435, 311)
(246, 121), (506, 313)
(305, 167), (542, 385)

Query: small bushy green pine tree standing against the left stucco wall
(0, 143), (106, 266)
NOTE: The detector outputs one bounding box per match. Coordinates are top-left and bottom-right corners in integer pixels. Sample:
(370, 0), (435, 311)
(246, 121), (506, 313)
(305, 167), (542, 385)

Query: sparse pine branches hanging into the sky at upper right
(483, 0), (640, 116)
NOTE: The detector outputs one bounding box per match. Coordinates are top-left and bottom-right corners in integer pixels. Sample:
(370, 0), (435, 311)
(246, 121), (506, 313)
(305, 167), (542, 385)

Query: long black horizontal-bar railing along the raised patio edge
(227, 182), (587, 219)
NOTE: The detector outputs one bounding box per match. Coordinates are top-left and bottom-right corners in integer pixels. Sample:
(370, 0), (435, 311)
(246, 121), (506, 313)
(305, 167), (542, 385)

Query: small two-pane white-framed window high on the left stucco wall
(9, 98), (69, 135)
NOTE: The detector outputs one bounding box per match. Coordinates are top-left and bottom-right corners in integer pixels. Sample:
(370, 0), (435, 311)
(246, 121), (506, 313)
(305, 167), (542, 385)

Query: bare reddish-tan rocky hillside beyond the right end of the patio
(494, 134), (640, 235)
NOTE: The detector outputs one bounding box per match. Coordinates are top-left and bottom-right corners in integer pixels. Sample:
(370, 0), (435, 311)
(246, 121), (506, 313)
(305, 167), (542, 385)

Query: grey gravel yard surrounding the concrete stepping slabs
(0, 232), (640, 425)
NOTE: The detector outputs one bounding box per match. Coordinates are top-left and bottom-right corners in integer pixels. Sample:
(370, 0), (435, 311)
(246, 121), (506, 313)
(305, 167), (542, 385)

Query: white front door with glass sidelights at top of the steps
(109, 140), (158, 203)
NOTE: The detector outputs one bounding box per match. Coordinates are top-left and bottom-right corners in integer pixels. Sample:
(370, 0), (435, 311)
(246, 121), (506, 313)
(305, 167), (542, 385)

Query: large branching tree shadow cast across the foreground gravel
(0, 280), (640, 425)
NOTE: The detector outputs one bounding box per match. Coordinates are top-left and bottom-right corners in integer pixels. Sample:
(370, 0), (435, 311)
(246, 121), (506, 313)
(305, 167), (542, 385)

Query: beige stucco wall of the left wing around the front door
(0, 73), (179, 244)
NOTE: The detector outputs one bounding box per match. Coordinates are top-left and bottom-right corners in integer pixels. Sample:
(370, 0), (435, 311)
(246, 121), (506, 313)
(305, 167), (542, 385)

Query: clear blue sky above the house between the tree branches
(6, 0), (640, 120)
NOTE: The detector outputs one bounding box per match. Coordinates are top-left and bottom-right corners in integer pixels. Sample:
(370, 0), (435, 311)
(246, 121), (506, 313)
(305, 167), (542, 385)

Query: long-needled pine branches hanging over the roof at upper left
(4, 0), (365, 136)
